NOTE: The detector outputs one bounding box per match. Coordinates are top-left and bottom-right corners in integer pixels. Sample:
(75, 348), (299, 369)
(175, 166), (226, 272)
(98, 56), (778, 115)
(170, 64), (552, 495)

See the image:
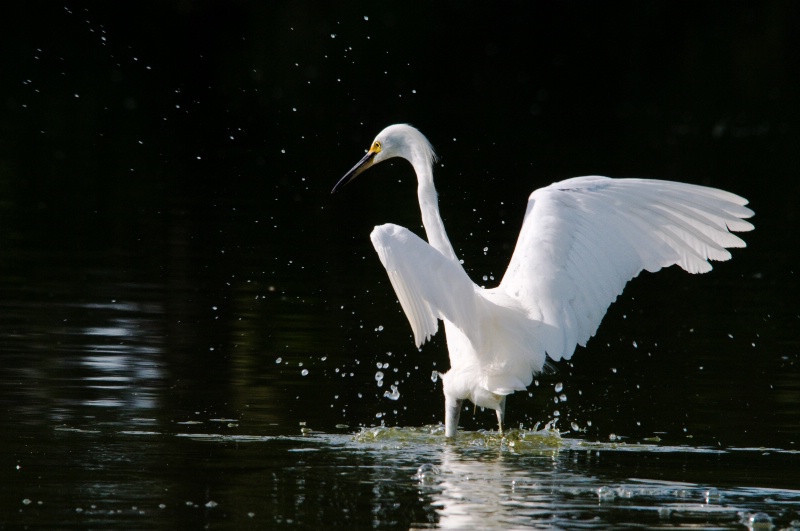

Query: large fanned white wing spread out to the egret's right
(497, 176), (753, 360)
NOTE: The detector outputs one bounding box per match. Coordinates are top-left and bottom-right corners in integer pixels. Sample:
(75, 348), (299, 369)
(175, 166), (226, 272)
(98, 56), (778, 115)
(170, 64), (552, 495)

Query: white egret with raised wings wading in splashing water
(331, 124), (753, 438)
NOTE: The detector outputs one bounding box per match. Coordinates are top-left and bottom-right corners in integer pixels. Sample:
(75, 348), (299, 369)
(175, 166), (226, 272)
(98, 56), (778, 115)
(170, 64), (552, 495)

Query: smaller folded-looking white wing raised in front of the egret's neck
(370, 223), (477, 346)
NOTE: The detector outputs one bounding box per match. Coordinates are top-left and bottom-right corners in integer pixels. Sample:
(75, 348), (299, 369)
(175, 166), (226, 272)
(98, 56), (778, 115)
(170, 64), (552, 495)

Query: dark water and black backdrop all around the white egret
(0, 2), (800, 529)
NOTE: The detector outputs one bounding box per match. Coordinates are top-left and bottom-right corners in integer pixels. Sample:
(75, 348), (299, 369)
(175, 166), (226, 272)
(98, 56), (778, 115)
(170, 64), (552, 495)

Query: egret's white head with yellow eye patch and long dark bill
(331, 124), (436, 193)
